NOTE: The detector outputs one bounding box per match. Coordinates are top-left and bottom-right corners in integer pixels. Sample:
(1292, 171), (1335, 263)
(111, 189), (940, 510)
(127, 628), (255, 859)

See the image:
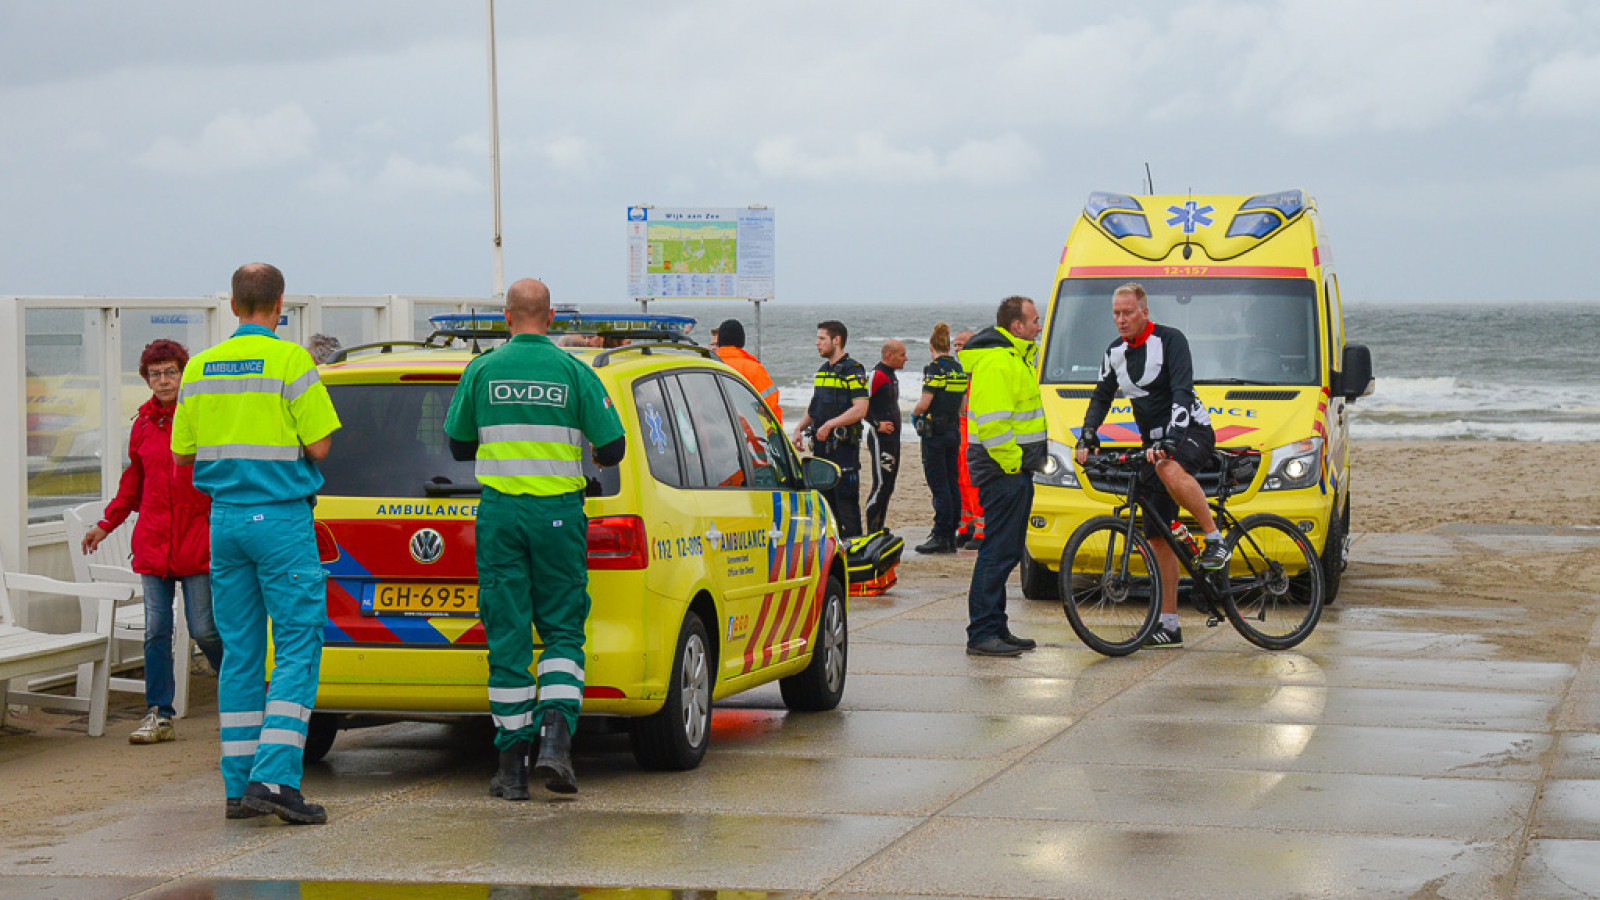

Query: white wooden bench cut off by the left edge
(0, 557), (133, 737)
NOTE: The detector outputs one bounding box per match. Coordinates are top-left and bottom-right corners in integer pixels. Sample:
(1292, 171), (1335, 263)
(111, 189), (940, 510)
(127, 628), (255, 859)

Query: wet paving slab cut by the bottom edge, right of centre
(838, 818), (1509, 900)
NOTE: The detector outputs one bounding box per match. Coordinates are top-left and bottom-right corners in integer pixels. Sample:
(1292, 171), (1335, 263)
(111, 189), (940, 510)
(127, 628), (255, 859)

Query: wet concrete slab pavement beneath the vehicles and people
(0, 532), (1600, 900)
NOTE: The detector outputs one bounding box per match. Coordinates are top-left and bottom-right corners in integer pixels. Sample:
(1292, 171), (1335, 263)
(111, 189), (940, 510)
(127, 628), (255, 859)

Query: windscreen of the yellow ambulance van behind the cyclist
(1040, 279), (1322, 384)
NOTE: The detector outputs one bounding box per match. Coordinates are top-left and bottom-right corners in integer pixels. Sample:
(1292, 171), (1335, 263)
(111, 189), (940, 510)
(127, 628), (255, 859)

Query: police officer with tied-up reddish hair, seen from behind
(912, 322), (966, 554)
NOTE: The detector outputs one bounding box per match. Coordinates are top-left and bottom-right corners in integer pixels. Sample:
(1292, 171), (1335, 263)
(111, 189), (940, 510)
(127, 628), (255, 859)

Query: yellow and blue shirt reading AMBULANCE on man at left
(173, 325), (339, 504)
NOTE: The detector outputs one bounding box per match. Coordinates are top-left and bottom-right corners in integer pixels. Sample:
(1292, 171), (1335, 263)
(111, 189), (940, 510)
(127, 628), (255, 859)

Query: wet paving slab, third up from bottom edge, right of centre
(1034, 717), (1554, 780)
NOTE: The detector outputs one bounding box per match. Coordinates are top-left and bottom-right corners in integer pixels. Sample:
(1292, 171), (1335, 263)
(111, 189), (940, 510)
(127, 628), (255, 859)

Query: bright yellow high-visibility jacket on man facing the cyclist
(962, 328), (1048, 484)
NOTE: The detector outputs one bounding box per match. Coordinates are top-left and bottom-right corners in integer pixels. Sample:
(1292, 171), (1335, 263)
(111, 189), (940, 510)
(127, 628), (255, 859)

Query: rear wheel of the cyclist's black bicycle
(1218, 512), (1323, 650)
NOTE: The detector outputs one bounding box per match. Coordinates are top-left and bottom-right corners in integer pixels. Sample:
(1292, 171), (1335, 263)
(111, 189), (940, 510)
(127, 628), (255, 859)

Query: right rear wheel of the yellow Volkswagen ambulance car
(629, 612), (712, 772)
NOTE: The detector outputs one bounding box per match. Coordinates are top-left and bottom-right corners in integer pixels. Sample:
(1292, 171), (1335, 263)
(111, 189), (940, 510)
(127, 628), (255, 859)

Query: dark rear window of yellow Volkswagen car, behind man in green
(318, 384), (621, 500)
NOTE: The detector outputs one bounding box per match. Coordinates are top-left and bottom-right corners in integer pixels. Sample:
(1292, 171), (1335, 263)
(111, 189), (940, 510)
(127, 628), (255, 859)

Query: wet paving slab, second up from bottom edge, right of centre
(949, 762), (1538, 841)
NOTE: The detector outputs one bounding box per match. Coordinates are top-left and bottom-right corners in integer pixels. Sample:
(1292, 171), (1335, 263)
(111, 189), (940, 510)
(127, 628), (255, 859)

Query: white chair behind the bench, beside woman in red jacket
(62, 503), (194, 719)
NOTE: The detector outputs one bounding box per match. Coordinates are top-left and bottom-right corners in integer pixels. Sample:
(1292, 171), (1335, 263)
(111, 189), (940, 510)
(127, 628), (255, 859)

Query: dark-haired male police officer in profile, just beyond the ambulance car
(794, 319), (867, 541)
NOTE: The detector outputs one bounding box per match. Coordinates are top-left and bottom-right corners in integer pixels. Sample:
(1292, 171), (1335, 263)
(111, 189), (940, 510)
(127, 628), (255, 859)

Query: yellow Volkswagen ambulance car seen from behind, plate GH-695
(296, 314), (848, 769)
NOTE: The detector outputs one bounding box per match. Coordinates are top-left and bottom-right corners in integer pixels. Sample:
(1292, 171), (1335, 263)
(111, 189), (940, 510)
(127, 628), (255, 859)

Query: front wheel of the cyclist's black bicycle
(1061, 516), (1162, 657)
